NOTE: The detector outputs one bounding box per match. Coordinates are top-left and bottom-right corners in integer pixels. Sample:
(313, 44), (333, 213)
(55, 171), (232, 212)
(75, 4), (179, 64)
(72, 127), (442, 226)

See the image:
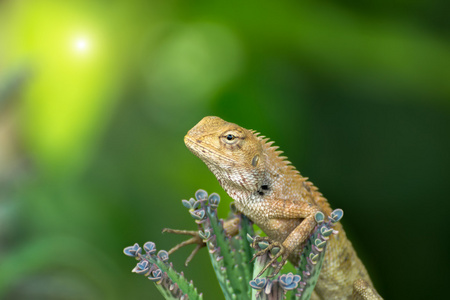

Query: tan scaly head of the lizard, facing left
(184, 117), (264, 189)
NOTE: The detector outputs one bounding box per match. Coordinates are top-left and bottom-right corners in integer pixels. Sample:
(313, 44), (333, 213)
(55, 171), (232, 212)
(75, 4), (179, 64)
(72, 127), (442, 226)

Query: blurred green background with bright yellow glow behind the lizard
(0, 0), (450, 299)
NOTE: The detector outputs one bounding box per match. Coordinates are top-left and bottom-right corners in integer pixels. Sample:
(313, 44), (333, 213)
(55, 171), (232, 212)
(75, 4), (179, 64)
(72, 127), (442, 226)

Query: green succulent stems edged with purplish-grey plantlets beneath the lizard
(124, 190), (343, 300)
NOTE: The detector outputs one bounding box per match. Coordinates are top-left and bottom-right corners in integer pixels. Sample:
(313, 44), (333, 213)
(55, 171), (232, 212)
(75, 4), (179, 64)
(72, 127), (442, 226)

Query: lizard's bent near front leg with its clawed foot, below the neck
(252, 200), (320, 277)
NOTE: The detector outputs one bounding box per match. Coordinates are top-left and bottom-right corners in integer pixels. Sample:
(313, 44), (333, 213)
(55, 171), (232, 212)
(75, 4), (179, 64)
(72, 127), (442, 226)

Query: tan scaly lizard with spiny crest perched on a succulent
(165, 116), (382, 300)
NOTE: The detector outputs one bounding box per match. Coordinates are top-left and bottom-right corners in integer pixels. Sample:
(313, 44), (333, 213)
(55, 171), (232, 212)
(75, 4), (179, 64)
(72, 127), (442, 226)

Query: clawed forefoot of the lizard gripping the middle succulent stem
(250, 236), (289, 278)
